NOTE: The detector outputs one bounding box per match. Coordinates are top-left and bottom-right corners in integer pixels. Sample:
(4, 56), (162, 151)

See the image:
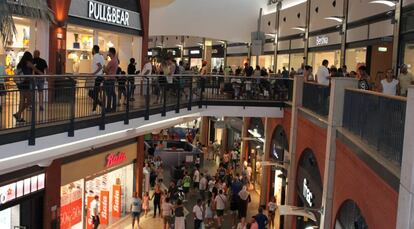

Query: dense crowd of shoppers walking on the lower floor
(127, 137), (277, 229)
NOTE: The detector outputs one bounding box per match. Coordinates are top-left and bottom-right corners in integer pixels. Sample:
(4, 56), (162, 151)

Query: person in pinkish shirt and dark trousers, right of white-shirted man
(104, 47), (119, 112)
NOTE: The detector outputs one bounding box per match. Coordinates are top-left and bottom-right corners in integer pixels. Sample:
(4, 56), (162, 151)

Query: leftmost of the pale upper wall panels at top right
(279, 3), (306, 37)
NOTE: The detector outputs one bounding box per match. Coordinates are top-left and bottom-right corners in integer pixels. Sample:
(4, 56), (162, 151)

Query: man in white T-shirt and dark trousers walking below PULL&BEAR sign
(89, 45), (105, 114)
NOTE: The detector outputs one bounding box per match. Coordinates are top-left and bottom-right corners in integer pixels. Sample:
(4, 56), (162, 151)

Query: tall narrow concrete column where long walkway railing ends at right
(285, 76), (304, 229)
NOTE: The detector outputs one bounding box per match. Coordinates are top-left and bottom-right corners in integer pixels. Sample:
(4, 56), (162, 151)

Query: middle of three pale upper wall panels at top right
(309, 0), (342, 32)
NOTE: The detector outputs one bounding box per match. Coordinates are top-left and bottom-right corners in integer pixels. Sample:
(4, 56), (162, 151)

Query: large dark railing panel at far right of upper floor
(343, 89), (407, 165)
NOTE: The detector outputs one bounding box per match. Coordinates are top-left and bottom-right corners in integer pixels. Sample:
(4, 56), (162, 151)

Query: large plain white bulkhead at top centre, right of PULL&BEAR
(149, 0), (267, 42)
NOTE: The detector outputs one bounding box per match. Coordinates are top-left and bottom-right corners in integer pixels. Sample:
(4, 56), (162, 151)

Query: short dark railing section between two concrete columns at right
(302, 82), (331, 117)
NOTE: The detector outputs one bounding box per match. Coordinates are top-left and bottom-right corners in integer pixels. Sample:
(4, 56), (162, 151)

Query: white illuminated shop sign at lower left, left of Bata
(0, 173), (45, 205)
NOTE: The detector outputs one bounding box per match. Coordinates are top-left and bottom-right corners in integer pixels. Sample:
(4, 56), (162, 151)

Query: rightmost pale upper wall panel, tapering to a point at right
(348, 0), (392, 22)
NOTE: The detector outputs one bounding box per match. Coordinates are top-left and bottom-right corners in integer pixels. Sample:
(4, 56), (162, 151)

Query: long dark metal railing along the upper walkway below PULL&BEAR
(0, 75), (293, 145)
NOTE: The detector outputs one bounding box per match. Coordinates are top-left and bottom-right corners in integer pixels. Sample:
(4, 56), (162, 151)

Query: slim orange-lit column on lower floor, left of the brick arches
(260, 118), (272, 206)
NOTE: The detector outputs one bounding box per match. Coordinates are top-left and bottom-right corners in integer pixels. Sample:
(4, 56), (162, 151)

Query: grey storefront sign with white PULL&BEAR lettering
(69, 0), (141, 30)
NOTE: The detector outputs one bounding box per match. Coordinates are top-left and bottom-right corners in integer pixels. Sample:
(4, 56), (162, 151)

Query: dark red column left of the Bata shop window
(43, 160), (61, 229)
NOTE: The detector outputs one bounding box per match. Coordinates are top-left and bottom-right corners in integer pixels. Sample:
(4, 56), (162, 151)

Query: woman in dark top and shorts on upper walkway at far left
(13, 52), (41, 122)
